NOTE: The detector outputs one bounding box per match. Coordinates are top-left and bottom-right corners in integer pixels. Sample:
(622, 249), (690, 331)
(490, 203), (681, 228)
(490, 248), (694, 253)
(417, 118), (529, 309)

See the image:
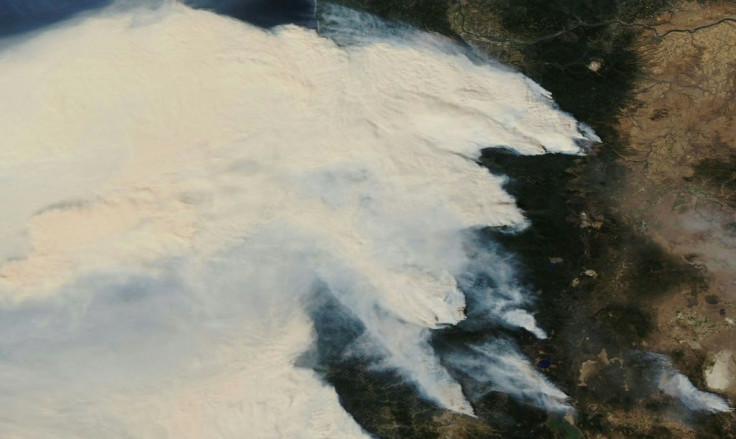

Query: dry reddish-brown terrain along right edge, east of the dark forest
(611, 2), (736, 399)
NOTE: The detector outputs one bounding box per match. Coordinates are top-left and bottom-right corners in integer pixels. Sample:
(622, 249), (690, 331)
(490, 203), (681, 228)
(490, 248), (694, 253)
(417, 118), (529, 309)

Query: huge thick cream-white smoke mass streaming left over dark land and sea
(0, 2), (596, 438)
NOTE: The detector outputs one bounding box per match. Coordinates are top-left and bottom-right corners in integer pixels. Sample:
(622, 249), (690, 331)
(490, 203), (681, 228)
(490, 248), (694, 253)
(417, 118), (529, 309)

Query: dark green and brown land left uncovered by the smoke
(318, 0), (736, 438)
